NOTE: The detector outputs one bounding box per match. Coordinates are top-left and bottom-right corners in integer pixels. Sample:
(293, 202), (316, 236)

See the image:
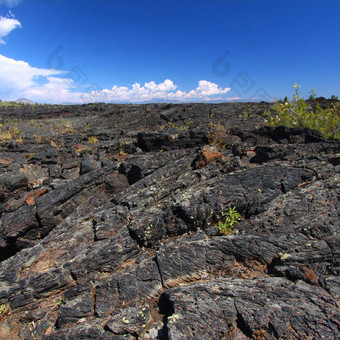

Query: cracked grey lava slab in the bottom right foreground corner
(162, 278), (339, 339)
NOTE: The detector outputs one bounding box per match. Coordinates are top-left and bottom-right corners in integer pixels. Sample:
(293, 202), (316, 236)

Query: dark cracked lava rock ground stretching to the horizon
(0, 103), (340, 340)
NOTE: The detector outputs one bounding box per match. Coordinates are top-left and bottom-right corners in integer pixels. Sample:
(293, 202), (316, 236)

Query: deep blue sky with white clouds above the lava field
(0, 0), (340, 103)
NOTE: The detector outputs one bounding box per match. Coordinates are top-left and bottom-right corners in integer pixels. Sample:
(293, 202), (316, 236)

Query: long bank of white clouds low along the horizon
(0, 54), (230, 103)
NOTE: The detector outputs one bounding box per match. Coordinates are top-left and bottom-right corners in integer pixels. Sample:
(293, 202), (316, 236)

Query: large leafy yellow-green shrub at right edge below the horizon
(265, 83), (340, 140)
